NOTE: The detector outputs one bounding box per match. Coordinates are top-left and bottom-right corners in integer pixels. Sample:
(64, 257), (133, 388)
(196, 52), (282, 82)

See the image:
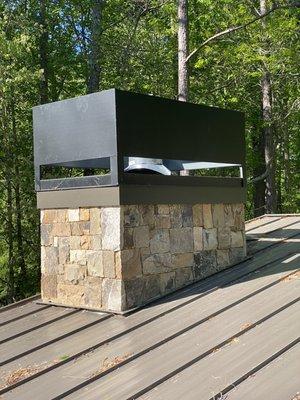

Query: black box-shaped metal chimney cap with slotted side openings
(33, 89), (245, 203)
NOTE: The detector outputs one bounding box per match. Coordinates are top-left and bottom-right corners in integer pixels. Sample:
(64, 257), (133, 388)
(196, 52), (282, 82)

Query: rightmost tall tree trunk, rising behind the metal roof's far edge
(260, 0), (277, 213)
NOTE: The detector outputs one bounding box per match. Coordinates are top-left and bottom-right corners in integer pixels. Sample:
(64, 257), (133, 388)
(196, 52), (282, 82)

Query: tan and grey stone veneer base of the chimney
(41, 204), (246, 312)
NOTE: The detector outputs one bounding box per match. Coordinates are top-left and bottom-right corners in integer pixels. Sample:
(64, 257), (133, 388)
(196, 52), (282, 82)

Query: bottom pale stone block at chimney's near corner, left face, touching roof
(102, 278), (127, 311)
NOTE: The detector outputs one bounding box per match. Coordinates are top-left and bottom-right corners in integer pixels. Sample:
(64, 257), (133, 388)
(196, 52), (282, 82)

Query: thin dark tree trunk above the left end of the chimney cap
(39, 0), (49, 104)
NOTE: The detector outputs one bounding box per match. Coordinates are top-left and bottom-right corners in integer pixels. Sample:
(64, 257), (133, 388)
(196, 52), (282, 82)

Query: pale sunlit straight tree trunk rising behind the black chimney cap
(178, 0), (189, 101)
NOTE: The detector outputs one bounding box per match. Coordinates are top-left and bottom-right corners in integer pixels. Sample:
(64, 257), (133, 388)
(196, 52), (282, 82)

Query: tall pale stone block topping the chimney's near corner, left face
(101, 207), (121, 251)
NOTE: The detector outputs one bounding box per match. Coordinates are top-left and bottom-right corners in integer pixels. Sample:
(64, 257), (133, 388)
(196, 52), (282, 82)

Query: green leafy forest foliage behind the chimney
(0, 0), (300, 304)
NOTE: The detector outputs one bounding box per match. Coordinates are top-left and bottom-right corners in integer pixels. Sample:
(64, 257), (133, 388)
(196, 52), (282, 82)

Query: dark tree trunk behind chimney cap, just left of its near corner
(87, 0), (104, 93)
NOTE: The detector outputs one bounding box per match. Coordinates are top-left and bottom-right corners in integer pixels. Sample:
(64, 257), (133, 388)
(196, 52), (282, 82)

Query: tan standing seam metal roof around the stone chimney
(0, 215), (300, 400)
